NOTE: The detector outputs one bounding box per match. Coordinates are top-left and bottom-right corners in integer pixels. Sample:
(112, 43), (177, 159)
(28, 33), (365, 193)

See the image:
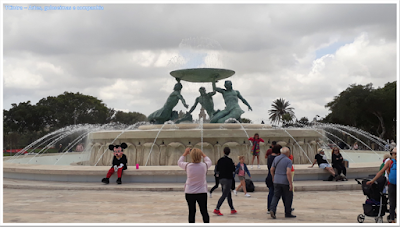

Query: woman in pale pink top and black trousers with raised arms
(178, 148), (212, 223)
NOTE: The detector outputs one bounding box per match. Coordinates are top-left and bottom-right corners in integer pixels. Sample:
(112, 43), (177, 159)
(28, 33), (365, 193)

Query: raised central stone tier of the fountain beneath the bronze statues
(88, 124), (323, 166)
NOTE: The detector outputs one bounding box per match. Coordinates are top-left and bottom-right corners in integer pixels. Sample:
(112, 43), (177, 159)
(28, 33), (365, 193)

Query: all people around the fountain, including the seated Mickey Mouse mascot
(102, 134), (397, 223)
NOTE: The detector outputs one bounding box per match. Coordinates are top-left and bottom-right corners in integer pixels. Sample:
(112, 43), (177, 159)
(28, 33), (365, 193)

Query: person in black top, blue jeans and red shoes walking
(214, 147), (237, 216)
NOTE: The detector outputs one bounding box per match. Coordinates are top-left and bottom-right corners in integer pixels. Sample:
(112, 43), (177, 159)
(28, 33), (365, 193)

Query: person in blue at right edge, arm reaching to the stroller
(367, 147), (397, 223)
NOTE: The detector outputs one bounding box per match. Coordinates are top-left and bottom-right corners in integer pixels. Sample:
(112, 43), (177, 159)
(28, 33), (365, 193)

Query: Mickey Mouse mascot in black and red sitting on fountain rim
(101, 143), (128, 184)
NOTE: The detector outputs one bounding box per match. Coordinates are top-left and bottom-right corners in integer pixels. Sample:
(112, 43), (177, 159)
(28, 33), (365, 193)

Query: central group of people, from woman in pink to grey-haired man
(178, 134), (296, 223)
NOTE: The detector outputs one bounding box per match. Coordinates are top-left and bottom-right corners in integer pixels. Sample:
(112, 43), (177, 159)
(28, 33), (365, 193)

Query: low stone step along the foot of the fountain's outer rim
(3, 178), (361, 192)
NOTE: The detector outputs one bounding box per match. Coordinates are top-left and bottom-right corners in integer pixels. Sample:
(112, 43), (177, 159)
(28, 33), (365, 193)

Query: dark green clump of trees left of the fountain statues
(3, 92), (147, 149)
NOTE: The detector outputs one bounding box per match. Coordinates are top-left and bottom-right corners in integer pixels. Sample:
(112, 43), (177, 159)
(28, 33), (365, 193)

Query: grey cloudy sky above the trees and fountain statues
(2, 3), (397, 123)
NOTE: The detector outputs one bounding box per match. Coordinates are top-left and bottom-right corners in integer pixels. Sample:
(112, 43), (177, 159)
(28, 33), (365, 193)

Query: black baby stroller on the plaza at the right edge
(355, 176), (389, 223)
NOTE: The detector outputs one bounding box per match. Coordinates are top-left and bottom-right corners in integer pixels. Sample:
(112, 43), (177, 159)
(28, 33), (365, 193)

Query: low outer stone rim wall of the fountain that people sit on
(3, 162), (380, 184)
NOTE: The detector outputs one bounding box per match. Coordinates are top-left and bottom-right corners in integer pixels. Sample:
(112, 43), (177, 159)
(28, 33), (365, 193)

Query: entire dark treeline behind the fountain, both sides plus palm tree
(3, 81), (397, 149)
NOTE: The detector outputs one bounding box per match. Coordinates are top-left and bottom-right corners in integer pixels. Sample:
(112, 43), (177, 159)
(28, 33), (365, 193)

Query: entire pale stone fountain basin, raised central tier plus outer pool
(3, 124), (386, 183)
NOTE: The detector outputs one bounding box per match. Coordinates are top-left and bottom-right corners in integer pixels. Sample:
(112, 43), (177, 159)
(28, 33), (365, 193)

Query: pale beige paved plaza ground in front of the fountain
(3, 185), (386, 224)
